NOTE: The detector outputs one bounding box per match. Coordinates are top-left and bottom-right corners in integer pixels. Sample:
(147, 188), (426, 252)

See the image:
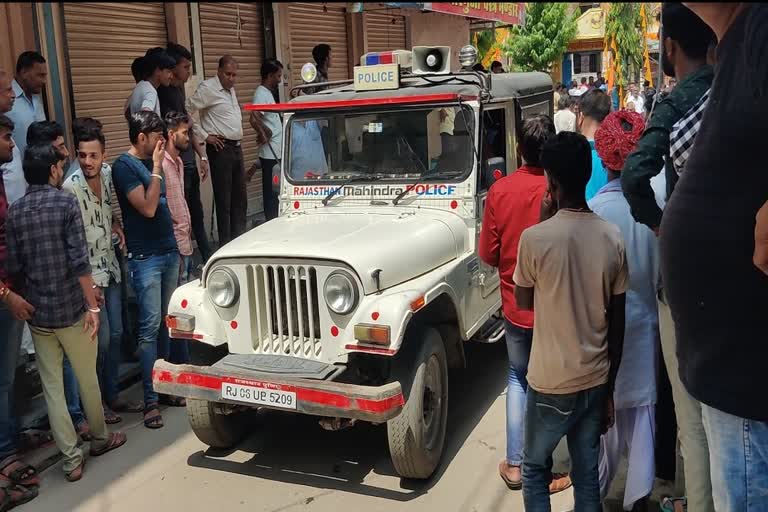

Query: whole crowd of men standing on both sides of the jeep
(0, 3), (768, 512)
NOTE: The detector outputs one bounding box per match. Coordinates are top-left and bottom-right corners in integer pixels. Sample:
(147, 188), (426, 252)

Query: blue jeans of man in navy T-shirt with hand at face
(128, 251), (179, 403)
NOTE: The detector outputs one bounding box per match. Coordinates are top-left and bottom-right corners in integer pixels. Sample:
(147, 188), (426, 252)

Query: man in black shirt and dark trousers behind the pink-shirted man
(157, 43), (211, 263)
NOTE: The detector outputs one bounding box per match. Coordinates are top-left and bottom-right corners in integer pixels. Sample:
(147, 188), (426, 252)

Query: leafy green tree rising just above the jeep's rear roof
(502, 2), (577, 73)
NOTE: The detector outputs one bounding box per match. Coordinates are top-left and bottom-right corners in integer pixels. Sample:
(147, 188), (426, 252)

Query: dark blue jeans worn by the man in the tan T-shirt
(523, 384), (608, 512)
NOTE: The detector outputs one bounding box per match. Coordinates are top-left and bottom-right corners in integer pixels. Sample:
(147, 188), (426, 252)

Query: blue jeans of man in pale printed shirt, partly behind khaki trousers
(64, 279), (123, 420)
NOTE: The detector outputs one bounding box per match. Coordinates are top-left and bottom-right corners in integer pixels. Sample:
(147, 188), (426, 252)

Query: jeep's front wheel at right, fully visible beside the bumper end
(387, 328), (448, 480)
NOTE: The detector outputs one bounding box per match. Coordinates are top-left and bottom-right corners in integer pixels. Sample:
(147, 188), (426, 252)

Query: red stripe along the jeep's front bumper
(153, 370), (405, 413)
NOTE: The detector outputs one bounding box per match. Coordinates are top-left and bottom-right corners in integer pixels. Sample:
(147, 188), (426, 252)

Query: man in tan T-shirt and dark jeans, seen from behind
(514, 132), (629, 512)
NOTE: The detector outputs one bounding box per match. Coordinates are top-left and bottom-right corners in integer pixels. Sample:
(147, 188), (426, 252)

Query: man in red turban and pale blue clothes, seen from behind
(589, 110), (659, 510)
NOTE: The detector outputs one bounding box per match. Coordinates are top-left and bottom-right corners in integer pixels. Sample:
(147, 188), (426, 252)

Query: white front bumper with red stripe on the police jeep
(152, 360), (405, 423)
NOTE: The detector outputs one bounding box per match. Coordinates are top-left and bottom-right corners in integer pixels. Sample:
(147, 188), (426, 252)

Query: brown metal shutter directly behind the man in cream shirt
(200, 2), (264, 218)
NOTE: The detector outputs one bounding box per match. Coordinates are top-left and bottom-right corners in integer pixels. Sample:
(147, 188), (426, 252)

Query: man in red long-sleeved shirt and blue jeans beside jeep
(479, 115), (570, 492)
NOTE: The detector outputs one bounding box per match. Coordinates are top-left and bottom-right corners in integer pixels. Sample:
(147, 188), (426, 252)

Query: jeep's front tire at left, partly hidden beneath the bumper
(187, 398), (246, 448)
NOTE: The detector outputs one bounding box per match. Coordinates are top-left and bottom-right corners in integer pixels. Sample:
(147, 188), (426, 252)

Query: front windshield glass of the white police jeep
(288, 106), (474, 183)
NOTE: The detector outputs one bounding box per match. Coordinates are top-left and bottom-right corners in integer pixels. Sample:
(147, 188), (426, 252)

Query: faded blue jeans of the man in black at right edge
(701, 404), (768, 512)
